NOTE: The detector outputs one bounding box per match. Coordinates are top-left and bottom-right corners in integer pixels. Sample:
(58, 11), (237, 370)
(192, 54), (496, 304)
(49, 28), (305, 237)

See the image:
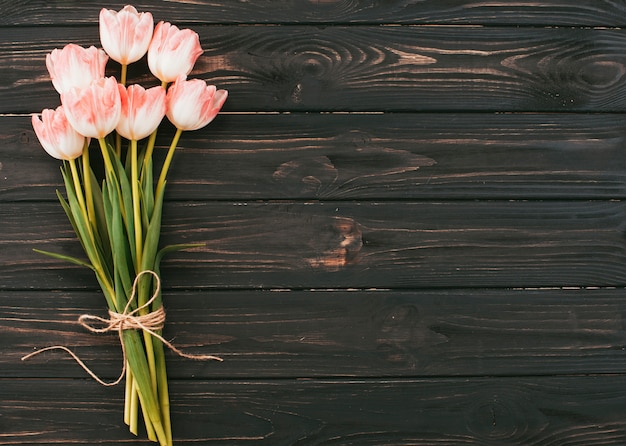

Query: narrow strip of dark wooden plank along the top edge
(0, 0), (626, 26)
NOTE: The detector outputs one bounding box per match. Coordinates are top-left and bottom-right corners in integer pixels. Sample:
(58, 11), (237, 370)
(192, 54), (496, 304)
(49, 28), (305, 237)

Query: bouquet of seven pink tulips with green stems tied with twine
(29, 6), (227, 446)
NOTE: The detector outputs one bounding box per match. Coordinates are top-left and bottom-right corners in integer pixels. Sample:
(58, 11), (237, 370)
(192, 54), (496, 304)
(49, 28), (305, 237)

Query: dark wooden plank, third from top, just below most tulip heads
(0, 113), (626, 201)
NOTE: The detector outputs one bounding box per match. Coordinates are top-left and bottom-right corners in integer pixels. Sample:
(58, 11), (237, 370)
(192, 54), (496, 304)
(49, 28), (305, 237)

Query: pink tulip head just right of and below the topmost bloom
(148, 22), (202, 82)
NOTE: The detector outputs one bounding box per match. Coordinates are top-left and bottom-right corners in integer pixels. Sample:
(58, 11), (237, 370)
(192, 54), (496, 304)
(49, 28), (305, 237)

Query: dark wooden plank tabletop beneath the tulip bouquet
(0, 0), (626, 446)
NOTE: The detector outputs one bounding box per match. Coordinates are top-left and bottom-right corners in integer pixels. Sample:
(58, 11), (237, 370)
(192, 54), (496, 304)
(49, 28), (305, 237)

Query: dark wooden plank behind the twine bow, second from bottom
(7, 289), (626, 381)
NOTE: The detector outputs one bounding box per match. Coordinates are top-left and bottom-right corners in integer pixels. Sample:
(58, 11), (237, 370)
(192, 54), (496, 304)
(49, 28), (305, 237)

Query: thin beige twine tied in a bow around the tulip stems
(22, 270), (223, 386)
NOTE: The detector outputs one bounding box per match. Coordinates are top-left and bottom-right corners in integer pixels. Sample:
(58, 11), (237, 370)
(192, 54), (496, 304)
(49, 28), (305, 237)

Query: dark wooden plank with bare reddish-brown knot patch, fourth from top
(0, 201), (626, 290)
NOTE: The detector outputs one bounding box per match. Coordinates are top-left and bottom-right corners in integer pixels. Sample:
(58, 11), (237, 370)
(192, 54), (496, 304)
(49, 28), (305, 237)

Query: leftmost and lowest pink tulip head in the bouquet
(32, 106), (85, 160)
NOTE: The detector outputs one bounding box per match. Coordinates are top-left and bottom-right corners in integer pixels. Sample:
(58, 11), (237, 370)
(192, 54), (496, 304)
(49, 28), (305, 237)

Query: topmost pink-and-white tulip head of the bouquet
(100, 5), (154, 65)
